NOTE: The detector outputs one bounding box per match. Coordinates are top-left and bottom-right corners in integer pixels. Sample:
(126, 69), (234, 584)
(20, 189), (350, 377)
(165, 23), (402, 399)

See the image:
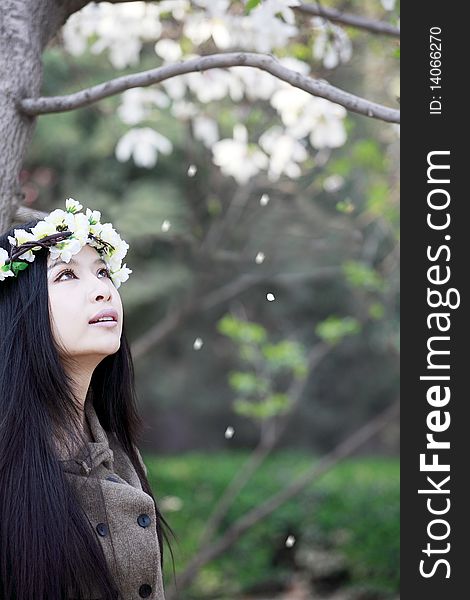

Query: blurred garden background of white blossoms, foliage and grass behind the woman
(21, 0), (399, 600)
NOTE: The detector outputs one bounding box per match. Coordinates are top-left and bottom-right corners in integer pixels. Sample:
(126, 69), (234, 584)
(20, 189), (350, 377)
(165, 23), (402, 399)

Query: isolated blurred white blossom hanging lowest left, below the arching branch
(116, 127), (173, 168)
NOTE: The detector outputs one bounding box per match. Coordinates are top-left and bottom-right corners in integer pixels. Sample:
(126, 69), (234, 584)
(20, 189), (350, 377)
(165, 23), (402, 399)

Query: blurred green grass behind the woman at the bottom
(144, 450), (400, 598)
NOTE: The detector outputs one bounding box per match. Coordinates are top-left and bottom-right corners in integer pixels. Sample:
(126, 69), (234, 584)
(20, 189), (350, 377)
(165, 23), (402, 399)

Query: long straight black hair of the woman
(0, 219), (176, 600)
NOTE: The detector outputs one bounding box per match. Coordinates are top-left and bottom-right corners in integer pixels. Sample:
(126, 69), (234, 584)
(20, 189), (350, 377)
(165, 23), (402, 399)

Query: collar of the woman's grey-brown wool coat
(60, 395), (114, 475)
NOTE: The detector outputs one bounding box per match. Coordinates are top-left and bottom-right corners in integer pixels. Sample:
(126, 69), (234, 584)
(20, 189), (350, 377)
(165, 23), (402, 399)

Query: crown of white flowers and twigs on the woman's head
(0, 198), (132, 288)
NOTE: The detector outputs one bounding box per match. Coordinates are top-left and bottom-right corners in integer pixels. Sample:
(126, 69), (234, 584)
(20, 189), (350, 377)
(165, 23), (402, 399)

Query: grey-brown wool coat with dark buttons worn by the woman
(61, 398), (165, 600)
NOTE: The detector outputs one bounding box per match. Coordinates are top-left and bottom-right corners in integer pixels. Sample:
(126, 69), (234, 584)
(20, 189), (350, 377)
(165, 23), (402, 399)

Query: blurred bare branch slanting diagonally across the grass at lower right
(165, 401), (399, 600)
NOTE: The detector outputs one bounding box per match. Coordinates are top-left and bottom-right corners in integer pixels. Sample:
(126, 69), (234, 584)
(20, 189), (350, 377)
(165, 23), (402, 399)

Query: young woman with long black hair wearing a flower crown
(0, 199), (174, 600)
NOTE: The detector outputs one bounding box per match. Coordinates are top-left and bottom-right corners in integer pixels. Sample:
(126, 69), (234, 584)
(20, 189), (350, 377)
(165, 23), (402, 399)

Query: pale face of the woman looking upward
(47, 244), (123, 365)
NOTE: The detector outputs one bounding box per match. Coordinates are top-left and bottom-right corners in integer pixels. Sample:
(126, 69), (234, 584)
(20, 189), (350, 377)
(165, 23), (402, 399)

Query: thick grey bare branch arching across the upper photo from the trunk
(16, 52), (400, 123)
